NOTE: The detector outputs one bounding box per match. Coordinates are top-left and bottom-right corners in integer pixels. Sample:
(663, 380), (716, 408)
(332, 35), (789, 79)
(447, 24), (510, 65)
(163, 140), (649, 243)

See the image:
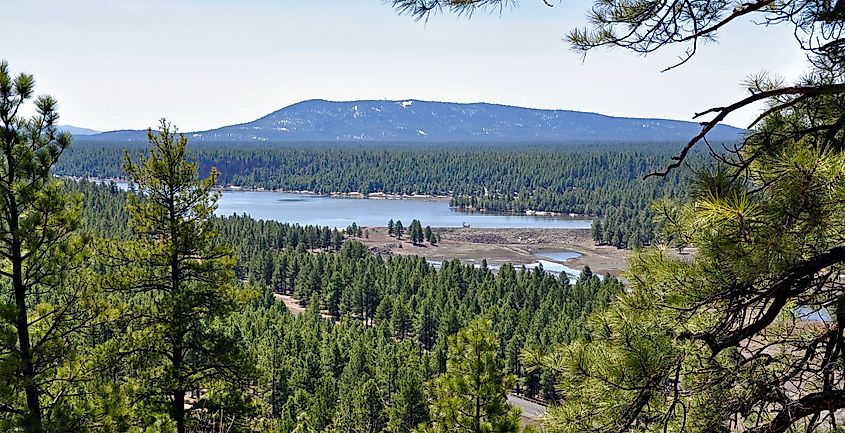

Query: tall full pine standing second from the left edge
(114, 120), (251, 433)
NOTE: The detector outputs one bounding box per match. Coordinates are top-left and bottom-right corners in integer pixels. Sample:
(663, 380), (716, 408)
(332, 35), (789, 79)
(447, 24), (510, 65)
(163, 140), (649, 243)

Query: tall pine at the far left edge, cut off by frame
(0, 61), (94, 433)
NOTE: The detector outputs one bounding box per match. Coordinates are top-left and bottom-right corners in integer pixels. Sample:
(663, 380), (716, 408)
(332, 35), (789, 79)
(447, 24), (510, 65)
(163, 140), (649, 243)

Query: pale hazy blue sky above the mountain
(0, 0), (806, 131)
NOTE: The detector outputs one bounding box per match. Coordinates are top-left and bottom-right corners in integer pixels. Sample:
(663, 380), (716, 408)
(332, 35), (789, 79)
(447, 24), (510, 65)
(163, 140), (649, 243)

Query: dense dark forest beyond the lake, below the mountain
(56, 138), (697, 248)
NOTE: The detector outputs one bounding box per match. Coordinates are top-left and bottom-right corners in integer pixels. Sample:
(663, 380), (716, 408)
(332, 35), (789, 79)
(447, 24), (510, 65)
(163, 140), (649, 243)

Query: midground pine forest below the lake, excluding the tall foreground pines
(46, 166), (622, 432)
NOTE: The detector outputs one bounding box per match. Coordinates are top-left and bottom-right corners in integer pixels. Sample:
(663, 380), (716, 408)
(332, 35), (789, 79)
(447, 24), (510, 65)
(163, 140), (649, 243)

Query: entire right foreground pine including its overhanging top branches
(393, 0), (845, 433)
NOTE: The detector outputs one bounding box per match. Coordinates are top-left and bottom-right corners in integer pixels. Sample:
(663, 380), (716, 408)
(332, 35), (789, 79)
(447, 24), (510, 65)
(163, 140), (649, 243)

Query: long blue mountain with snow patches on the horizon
(82, 99), (743, 142)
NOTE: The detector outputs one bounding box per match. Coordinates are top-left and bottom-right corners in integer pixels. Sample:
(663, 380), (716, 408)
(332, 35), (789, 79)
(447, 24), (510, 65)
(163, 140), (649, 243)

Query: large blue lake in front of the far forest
(217, 191), (592, 229)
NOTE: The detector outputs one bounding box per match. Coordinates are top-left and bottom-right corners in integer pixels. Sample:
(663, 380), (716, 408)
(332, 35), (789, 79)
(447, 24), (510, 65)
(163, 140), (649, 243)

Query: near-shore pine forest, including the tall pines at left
(0, 71), (622, 433)
